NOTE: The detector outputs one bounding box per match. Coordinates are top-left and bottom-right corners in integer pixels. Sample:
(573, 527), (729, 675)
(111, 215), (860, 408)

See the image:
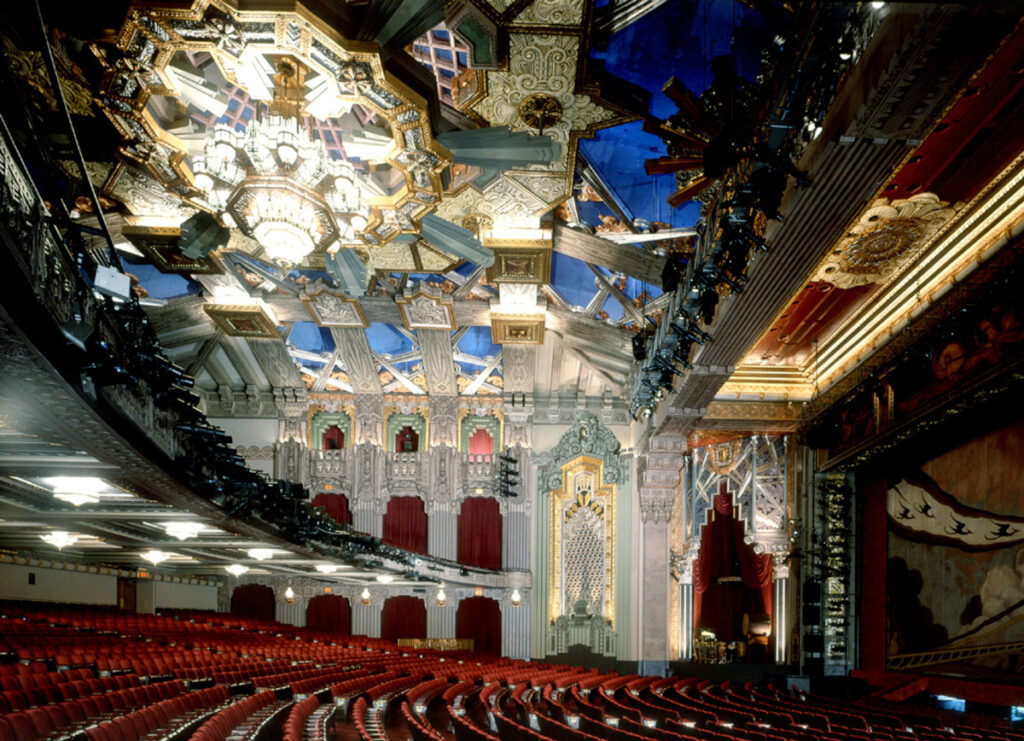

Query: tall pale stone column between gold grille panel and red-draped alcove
(638, 435), (686, 677)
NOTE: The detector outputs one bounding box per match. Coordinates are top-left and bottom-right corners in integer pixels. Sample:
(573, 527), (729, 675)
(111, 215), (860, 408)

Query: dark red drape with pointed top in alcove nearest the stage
(693, 486), (773, 641)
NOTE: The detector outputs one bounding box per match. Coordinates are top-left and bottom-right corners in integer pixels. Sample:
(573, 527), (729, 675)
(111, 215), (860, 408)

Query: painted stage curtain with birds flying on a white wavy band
(886, 418), (1024, 672)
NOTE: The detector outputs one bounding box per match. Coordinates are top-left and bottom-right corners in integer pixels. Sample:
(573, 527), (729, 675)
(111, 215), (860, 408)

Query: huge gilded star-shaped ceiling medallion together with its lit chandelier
(93, 0), (451, 267)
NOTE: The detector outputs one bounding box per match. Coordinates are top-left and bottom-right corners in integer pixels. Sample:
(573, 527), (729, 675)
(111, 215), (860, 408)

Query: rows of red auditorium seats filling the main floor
(0, 603), (1024, 741)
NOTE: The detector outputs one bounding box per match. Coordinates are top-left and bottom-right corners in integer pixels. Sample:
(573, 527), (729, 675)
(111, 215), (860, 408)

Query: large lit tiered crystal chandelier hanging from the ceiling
(193, 62), (371, 267)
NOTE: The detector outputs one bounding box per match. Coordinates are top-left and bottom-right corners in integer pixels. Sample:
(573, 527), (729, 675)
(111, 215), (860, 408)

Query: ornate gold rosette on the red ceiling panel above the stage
(811, 193), (961, 289)
